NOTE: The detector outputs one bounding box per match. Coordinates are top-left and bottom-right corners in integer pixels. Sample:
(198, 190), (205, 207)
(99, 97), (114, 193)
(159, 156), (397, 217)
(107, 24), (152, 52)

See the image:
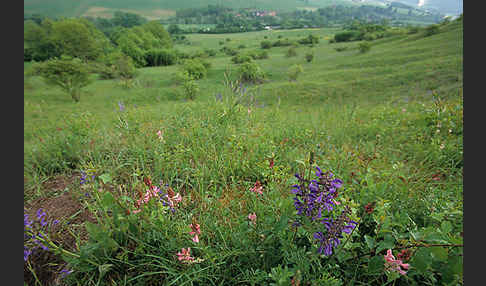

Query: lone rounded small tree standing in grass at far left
(33, 56), (91, 102)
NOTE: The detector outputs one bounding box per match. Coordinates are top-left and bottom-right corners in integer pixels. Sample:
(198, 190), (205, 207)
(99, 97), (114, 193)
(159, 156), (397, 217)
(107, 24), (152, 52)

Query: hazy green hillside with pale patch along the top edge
(24, 0), (350, 17)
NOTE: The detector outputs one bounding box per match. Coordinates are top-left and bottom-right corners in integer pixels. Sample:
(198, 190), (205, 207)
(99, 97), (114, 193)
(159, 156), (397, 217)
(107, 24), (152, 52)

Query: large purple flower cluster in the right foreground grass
(292, 167), (358, 256)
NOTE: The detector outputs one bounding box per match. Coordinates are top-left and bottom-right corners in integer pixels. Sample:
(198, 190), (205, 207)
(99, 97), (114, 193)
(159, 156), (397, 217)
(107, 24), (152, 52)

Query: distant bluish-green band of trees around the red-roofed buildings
(165, 5), (442, 33)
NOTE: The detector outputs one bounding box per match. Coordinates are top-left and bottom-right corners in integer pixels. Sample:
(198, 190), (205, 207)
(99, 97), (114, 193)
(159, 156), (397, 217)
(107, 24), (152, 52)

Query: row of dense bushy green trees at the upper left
(24, 18), (172, 67)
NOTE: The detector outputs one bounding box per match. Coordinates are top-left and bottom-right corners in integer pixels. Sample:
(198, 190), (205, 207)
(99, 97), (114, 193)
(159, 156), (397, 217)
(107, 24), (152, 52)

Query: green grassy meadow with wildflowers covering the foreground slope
(24, 20), (463, 285)
